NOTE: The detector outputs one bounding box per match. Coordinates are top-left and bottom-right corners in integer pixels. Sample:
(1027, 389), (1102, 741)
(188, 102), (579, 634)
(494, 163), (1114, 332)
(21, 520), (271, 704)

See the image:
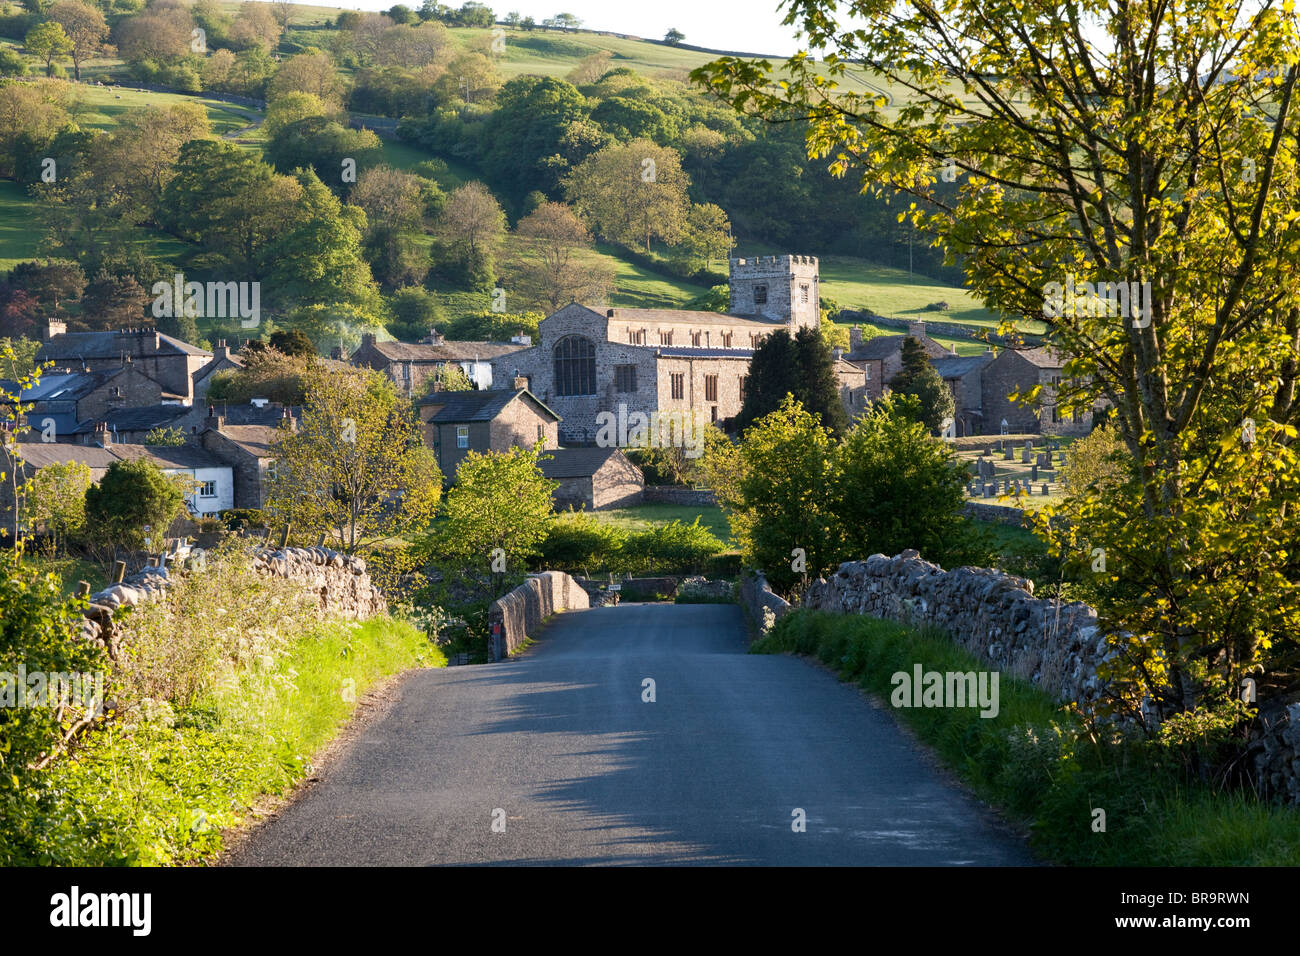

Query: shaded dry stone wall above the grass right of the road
(803, 550), (1114, 702)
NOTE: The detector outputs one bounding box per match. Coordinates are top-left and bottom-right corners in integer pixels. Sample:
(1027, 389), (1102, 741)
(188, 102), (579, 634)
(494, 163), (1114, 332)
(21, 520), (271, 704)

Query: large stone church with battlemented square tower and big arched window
(493, 255), (862, 445)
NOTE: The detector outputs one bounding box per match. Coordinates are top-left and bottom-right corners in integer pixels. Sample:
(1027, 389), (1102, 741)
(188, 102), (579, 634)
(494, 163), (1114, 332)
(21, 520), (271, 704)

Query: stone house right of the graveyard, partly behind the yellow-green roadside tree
(983, 347), (1092, 434)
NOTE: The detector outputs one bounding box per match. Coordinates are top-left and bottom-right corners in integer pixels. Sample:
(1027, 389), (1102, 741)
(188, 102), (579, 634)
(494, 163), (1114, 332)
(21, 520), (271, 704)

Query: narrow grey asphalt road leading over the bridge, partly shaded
(228, 605), (1034, 865)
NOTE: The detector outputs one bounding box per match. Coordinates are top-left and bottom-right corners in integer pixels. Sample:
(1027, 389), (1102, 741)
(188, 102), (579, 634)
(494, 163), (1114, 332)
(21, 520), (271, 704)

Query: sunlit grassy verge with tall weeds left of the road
(7, 617), (446, 866)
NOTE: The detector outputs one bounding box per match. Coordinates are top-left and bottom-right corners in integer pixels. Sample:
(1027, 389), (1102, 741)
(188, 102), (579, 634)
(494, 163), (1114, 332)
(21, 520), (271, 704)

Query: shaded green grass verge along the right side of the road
(753, 611), (1300, 866)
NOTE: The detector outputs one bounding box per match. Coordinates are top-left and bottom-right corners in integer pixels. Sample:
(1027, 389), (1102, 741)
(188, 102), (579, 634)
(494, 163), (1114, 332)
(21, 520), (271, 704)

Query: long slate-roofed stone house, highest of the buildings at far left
(36, 321), (212, 405)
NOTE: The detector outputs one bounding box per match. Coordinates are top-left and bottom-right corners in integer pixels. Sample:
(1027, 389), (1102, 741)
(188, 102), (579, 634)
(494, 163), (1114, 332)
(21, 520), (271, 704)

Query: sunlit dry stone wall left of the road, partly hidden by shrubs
(81, 548), (387, 659)
